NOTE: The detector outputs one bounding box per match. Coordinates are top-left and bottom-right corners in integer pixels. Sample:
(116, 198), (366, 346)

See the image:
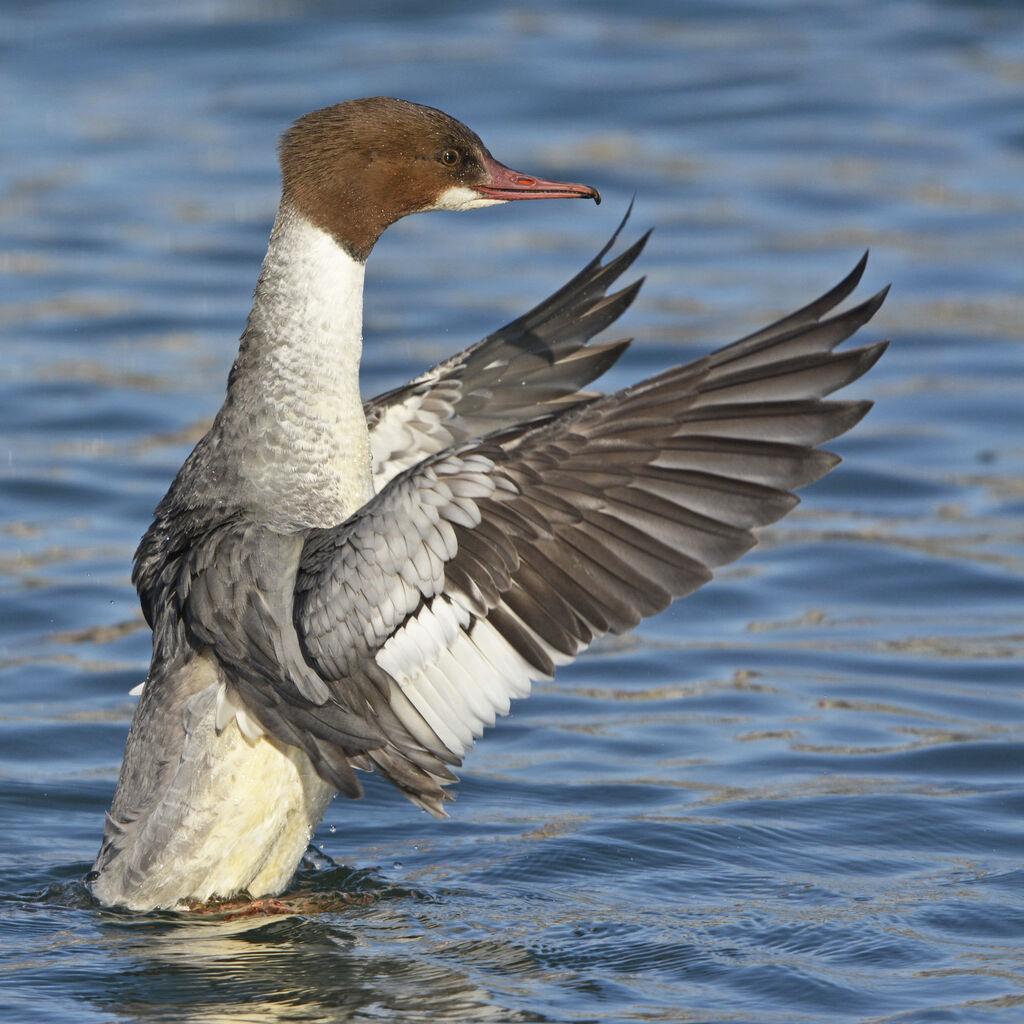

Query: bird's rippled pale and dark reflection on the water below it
(83, 870), (512, 1024)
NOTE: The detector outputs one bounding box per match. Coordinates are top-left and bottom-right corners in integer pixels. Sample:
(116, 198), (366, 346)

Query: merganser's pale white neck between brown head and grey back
(212, 204), (372, 529)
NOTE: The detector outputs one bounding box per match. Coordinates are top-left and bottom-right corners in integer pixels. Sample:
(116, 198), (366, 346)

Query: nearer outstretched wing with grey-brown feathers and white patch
(247, 264), (886, 814)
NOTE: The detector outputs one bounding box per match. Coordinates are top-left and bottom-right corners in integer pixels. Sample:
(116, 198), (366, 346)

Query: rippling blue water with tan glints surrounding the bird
(0, 0), (1024, 1024)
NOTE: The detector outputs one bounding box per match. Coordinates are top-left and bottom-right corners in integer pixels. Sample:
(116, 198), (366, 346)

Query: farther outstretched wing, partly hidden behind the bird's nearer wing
(364, 204), (650, 490)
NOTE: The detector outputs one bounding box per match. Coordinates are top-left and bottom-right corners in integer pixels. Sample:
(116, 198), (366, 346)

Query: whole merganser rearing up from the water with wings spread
(87, 97), (886, 911)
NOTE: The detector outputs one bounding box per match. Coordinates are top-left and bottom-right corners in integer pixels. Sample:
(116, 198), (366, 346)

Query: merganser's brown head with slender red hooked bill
(281, 96), (601, 260)
